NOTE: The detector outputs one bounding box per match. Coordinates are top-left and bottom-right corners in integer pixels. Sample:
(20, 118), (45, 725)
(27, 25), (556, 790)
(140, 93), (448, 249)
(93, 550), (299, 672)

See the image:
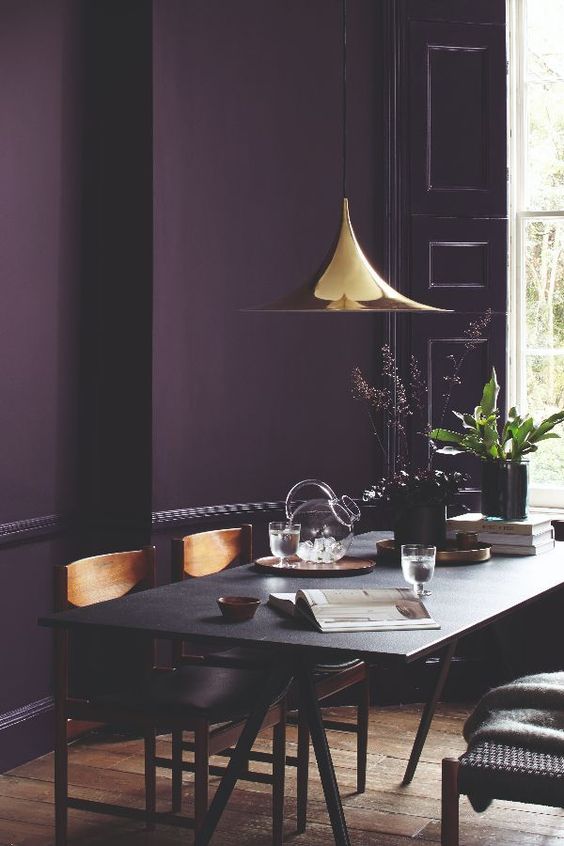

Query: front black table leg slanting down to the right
(296, 663), (350, 846)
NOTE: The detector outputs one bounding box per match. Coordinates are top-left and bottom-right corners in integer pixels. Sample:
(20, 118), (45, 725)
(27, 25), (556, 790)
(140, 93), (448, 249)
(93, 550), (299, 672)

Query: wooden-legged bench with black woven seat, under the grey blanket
(441, 741), (564, 846)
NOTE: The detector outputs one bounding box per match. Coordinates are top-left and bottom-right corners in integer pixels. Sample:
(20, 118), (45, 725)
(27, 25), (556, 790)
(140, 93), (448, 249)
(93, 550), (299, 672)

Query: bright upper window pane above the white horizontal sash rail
(525, 0), (564, 211)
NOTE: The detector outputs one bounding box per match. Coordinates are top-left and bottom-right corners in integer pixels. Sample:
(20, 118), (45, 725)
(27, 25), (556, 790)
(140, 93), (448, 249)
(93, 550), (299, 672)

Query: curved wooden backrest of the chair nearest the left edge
(55, 546), (155, 610)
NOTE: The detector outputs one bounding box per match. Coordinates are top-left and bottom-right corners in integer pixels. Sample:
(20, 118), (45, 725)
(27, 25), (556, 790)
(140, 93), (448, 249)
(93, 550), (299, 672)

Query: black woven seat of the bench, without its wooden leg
(458, 741), (564, 810)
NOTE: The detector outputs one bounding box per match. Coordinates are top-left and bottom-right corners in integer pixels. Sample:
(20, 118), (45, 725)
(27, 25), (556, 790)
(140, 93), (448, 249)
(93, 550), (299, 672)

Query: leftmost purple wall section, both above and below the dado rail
(0, 0), (80, 770)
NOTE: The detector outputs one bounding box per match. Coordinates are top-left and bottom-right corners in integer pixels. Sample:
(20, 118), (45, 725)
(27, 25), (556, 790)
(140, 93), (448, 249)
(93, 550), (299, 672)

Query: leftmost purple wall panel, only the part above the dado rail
(0, 0), (79, 522)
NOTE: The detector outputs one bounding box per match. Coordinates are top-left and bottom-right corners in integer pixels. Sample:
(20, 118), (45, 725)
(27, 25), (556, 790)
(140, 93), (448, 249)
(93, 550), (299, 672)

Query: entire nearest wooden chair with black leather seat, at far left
(55, 547), (286, 846)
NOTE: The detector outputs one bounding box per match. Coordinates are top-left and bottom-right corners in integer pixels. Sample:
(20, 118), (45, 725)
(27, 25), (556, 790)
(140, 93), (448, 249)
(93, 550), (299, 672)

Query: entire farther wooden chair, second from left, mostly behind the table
(165, 524), (370, 833)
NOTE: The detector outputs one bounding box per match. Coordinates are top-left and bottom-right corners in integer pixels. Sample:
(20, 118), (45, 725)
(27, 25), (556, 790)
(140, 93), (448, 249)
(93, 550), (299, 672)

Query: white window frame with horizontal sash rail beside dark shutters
(507, 0), (564, 510)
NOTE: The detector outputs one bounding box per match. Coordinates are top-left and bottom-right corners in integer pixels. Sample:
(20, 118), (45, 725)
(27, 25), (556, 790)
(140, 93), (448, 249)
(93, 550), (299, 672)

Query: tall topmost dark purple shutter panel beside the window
(408, 21), (506, 217)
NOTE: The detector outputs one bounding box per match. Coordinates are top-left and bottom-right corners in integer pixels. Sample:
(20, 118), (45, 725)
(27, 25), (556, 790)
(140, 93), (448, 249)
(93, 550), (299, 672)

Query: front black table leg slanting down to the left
(194, 664), (292, 846)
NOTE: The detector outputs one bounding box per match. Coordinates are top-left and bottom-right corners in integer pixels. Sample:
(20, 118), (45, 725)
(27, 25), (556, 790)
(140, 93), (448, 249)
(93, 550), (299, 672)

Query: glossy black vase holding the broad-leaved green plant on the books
(482, 461), (529, 520)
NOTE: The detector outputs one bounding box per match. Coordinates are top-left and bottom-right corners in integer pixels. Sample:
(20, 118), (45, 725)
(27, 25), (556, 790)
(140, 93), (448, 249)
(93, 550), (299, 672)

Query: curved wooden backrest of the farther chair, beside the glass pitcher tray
(172, 523), (253, 582)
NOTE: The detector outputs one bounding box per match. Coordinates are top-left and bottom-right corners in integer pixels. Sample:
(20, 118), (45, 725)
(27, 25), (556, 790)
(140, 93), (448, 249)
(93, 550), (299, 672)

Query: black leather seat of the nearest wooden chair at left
(96, 665), (285, 723)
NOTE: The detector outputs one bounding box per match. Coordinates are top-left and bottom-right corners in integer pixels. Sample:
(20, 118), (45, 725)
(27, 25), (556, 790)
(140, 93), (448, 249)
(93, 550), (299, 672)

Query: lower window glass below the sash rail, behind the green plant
(524, 219), (564, 485)
